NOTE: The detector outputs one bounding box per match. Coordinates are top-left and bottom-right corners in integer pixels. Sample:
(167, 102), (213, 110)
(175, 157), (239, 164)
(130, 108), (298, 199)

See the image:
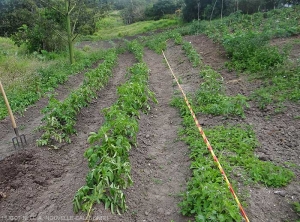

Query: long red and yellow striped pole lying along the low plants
(162, 51), (249, 222)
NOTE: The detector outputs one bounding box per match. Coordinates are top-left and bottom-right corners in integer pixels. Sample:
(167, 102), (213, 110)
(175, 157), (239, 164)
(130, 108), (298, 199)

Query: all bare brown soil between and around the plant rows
(0, 35), (300, 222)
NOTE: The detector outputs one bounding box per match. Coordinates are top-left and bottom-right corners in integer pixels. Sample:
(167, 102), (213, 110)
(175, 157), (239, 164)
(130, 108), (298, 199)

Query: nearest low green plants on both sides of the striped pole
(177, 102), (294, 221)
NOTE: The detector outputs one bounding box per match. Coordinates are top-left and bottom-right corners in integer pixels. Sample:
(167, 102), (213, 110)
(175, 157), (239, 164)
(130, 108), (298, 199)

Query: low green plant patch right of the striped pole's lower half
(202, 126), (294, 187)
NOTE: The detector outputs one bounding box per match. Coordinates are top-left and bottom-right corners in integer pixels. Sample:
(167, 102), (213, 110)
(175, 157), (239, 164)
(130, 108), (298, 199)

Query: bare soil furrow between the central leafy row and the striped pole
(95, 47), (190, 222)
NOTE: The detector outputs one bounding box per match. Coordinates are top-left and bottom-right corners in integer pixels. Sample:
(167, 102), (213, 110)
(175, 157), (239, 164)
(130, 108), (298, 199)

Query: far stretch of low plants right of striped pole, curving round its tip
(146, 31), (249, 117)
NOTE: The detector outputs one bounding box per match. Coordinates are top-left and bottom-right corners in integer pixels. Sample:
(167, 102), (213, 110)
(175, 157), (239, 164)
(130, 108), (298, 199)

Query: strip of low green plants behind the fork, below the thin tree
(0, 51), (104, 119)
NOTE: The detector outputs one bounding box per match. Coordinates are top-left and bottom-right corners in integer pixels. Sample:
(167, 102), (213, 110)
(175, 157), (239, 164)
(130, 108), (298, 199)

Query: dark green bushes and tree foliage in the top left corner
(0, 0), (99, 56)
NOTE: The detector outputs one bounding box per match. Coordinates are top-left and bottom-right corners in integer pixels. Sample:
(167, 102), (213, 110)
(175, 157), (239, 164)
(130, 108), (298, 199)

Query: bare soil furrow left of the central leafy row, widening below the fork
(0, 53), (135, 221)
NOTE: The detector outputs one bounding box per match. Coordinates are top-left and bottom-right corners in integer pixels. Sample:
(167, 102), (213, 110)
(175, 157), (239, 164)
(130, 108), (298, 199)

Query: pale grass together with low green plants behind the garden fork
(0, 38), (110, 119)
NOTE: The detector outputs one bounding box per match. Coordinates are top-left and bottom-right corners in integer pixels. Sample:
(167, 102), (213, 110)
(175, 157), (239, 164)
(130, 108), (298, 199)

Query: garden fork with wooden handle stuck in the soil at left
(0, 81), (27, 149)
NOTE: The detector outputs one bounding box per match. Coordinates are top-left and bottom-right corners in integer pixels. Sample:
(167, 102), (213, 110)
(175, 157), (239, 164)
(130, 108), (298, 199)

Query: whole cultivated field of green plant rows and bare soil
(0, 7), (300, 222)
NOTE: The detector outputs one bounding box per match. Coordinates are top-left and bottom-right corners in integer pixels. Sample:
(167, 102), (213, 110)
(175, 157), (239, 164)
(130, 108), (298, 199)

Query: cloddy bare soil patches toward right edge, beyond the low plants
(186, 35), (300, 222)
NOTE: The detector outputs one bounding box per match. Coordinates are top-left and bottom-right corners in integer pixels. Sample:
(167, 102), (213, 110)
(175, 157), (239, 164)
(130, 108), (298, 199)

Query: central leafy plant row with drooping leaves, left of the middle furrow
(73, 41), (157, 218)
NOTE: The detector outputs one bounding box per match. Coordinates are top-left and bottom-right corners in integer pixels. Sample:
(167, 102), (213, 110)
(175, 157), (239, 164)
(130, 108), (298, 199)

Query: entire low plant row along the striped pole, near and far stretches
(144, 34), (294, 221)
